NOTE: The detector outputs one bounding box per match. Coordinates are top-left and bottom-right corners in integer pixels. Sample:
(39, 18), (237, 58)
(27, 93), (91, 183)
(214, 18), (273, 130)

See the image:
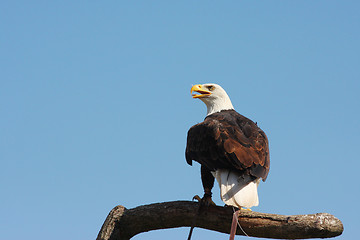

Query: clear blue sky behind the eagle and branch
(0, 0), (360, 240)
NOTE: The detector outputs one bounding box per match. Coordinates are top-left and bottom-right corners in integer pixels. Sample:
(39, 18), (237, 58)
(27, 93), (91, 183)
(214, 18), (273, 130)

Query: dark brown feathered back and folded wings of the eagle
(186, 110), (270, 181)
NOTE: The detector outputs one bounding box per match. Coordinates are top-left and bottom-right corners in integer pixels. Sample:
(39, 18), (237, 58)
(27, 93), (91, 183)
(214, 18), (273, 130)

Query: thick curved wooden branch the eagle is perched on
(97, 201), (343, 240)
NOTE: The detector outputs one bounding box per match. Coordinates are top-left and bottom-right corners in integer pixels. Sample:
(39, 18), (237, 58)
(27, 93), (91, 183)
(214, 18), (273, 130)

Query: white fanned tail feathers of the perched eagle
(213, 169), (260, 208)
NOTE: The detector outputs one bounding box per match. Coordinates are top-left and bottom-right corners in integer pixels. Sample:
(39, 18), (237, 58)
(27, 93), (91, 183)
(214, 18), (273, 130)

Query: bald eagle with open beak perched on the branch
(185, 84), (270, 208)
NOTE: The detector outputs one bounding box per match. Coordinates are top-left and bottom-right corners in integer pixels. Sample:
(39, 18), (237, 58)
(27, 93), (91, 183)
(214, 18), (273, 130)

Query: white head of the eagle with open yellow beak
(191, 83), (234, 116)
